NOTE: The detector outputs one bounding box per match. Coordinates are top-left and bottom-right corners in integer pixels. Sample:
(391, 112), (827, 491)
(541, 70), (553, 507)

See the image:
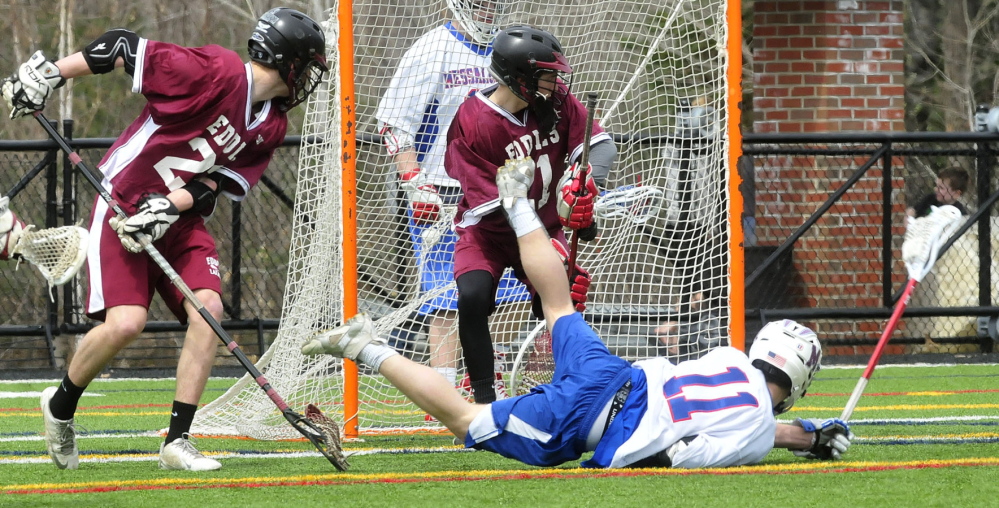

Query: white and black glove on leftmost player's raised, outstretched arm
(0, 51), (66, 119)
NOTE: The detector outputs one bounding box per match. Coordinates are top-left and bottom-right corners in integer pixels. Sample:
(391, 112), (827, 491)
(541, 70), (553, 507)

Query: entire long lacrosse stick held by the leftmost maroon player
(33, 111), (348, 471)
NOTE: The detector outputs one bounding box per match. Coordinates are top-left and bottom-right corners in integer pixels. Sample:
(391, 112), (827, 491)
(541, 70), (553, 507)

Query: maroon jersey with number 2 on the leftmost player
(99, 39), (288, 213)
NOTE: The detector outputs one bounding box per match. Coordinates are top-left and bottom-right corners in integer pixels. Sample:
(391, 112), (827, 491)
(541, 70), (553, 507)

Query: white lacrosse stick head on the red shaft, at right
(902, 205), (961, 281)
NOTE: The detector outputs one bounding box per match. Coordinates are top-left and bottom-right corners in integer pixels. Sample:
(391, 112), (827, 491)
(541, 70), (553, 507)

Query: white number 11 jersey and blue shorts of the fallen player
(465, 314), (777, 468)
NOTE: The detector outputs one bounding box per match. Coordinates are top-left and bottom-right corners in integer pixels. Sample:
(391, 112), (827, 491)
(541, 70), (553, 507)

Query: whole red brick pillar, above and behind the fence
(752, 0), (905, 354)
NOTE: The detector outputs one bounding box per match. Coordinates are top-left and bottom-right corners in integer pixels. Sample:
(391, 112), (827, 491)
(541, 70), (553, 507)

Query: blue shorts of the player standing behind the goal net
(406, 187), (531, 315)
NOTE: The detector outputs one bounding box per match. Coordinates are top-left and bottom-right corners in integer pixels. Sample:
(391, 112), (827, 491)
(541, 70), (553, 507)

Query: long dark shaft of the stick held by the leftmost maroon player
(28, 111), (288, 411)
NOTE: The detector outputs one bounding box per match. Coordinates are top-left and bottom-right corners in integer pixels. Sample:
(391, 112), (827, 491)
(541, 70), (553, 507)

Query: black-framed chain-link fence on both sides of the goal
(0, 127), (999, 372)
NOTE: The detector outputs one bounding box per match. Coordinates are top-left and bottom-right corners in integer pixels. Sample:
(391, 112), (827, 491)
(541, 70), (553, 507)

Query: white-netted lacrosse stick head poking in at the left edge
(12, 226), (90, 287)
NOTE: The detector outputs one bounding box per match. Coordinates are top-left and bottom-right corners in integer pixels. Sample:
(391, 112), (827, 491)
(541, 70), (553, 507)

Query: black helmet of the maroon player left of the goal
(247, 7), (329, 111)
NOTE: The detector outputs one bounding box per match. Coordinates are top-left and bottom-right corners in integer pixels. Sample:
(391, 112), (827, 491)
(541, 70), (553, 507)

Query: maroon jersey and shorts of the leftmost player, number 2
(86, 39), (288, 323)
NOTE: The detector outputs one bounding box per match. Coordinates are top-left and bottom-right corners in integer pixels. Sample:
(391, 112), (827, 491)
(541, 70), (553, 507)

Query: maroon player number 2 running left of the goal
(2, 8), (327, 471)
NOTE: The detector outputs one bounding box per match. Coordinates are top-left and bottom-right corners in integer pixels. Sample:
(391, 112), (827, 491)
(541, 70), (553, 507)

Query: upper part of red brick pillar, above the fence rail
(753, 0), (905, 133)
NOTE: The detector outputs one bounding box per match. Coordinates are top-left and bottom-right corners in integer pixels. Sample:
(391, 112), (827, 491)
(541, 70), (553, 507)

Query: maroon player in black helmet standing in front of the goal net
(444, 25), (617, 403)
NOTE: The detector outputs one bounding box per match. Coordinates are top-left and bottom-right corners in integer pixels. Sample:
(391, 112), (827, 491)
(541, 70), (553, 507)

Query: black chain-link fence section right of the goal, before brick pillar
(740, 133), (999, 361)
